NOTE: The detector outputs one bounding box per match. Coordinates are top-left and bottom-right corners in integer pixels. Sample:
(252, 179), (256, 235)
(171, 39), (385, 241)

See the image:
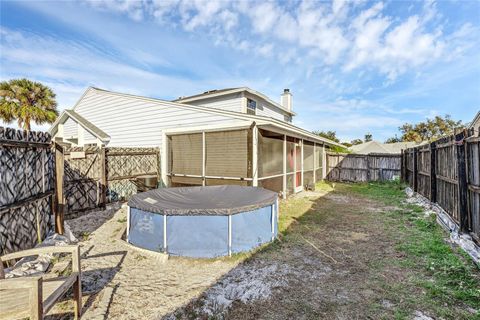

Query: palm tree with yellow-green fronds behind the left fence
(0, 79), (58, 131)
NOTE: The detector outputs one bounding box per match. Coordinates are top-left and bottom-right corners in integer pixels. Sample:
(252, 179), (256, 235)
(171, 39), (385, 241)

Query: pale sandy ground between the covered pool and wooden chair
(54, 208), (238, 319)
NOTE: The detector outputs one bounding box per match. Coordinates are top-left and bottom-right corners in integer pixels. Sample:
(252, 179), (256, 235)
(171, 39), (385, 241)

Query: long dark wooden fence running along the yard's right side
(402, 131), (480, 243)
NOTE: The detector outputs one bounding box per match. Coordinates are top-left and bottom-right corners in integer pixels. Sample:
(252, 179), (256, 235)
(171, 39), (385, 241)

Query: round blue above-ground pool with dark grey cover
(127, 186), (278, 258)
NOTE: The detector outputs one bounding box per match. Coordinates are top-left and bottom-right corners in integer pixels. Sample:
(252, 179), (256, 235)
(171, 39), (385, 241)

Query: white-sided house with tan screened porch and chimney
(49, 87), (340, 196)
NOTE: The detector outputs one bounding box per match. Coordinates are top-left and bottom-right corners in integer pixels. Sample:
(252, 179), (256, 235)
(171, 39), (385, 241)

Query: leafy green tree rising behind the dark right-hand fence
(399, 115), (463, 142)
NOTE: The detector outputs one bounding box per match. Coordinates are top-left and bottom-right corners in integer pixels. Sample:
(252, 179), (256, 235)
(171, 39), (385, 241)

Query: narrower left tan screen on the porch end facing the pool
(168, 133), (202, 176)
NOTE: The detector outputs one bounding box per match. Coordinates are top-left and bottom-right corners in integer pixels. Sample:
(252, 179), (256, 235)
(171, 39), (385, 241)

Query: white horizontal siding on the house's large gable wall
(74, 89), (251, 147)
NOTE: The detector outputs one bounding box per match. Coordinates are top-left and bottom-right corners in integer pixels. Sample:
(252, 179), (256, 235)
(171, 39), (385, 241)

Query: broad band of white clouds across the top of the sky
(78, 0), (472, 85)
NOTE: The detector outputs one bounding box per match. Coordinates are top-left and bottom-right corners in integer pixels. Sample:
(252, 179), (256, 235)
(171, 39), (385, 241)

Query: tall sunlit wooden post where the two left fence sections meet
(54, 143), (65, 234)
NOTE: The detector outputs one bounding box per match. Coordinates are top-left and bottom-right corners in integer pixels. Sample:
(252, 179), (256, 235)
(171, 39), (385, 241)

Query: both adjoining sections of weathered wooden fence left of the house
(0, 127), (159, 255)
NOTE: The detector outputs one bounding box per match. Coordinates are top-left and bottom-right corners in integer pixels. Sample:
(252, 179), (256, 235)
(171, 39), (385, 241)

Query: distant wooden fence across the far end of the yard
(327, 153), (402, 182)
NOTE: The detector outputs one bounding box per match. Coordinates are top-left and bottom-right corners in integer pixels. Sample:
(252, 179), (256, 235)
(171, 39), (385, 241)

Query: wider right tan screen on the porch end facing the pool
(205, 130), (249, 178)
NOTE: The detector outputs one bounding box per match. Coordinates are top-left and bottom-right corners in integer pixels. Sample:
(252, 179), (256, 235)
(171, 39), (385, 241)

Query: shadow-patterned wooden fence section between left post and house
(63, 147), (159, 216)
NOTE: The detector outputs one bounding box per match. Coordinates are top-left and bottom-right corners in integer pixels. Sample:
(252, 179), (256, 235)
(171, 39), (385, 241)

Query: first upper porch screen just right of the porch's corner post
(258, 130), (283, 178)
